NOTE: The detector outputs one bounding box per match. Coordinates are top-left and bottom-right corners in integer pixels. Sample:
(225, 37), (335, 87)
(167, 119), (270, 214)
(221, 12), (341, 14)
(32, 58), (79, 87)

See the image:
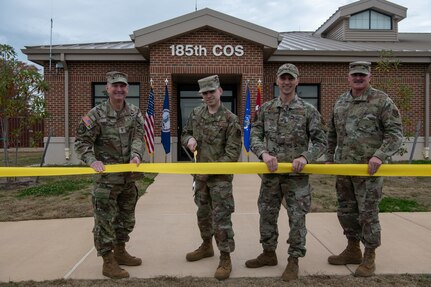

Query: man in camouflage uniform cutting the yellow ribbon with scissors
(181, 75), (242, 280)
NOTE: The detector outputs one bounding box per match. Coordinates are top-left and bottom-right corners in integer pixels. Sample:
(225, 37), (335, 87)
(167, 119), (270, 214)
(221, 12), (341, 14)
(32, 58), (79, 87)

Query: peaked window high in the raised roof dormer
(349, 10), (392, 30)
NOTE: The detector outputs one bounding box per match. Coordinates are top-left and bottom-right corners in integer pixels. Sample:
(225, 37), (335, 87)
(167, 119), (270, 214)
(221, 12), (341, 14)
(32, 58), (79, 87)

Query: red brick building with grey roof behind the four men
(23, 0), (431, 164)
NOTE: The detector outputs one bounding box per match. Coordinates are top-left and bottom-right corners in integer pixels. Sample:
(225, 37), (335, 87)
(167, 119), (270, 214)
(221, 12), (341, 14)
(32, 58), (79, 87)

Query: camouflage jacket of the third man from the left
(250, 95), (327, 163)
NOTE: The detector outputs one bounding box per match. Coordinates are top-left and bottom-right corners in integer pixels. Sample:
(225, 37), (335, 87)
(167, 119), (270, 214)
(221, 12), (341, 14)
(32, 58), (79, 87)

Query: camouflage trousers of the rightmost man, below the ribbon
(336, 176), (383, 248)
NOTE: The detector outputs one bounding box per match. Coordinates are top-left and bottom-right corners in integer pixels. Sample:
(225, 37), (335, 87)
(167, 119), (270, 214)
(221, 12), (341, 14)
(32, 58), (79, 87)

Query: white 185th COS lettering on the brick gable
(169, 45), (244, 57)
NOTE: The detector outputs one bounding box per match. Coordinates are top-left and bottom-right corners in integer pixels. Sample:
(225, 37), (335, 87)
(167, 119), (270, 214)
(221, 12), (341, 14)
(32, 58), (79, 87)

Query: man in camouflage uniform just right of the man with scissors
(245, 64), (327, 281)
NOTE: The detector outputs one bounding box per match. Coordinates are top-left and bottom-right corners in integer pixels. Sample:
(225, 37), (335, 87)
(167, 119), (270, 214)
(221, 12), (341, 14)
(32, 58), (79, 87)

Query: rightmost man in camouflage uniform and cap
(328, 62), (403, 277)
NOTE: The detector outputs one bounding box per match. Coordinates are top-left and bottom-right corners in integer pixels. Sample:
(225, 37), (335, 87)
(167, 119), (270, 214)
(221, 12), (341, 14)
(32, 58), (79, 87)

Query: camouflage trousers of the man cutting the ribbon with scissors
(195, 175), (235, 253)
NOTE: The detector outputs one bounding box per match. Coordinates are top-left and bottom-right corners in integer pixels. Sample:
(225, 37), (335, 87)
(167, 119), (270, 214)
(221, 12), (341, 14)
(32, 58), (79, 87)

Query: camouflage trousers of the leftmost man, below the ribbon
(92, 182), (138, 256)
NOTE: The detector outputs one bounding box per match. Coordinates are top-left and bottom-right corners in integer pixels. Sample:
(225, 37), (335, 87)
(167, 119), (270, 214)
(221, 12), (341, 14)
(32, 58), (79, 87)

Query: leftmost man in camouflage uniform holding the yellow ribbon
(75, 72), (145, 278)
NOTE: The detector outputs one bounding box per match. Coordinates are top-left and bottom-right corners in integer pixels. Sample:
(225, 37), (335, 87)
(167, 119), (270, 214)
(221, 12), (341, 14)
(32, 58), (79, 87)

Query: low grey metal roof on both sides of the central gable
(23, 32), (431, 63)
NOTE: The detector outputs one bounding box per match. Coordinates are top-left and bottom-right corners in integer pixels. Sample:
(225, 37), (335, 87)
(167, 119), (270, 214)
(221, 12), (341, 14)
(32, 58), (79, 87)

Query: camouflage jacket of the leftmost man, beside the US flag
(75, 101), (145, 184)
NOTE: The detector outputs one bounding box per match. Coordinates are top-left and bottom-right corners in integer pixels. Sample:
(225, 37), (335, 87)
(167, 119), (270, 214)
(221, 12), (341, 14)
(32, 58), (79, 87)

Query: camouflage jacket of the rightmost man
(327, 86), (403, 163)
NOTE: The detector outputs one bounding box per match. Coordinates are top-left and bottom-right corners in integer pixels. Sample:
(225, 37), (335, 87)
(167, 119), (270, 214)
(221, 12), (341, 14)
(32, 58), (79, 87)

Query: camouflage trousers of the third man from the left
(257, 174), (311, 257)
